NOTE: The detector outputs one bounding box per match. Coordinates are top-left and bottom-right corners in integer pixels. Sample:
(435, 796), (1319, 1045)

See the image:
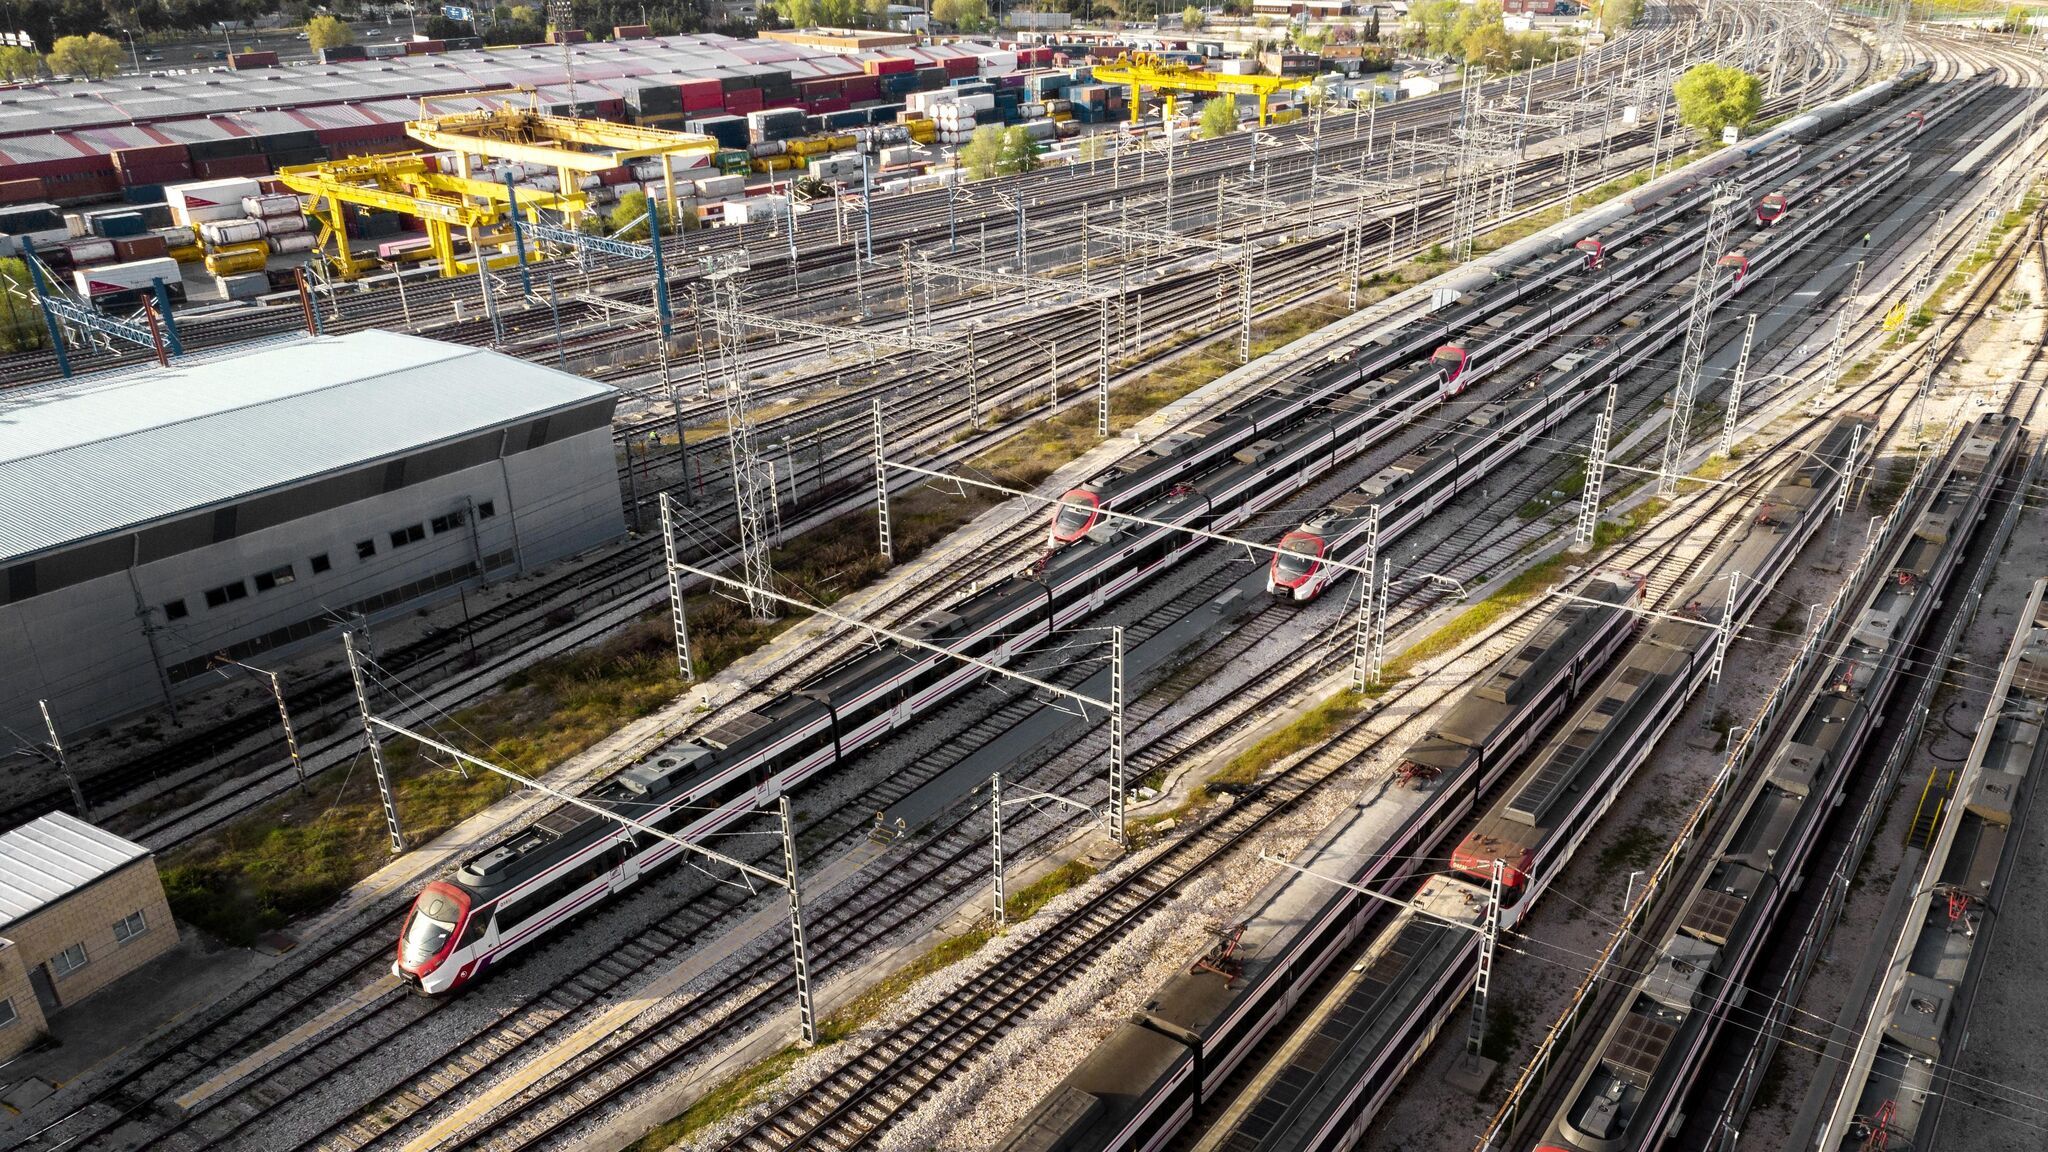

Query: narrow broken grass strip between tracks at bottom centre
(633, 861), (1096, 1152)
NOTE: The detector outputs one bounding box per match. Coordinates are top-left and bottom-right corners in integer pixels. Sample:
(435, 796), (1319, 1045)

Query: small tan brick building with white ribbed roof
(0, 812), (178, 1060)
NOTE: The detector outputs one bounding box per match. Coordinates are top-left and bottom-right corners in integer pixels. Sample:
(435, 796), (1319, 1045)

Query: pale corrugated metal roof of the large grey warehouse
(0, 330), (612, 564)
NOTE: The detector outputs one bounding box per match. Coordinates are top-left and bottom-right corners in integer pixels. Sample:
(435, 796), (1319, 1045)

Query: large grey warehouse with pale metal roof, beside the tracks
(0, 332), (625, 732)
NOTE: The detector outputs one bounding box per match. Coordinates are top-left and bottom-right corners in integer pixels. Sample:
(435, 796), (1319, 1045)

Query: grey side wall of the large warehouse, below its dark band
(0, 422), (625, 736)
